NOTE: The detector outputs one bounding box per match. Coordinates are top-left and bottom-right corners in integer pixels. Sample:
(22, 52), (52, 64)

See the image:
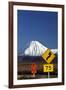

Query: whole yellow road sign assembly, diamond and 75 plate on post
(42, 49), (55, 78)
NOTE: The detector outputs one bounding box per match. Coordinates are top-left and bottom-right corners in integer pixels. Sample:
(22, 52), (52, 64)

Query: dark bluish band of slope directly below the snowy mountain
(18, 54), (57, 64)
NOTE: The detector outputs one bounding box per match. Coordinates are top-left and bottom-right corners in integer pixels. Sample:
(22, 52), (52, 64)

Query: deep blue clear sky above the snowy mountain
(17, 10), (58, 52)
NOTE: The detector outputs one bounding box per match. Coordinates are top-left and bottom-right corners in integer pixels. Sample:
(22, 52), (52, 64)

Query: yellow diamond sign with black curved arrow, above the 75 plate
(42, 49), (55, 63)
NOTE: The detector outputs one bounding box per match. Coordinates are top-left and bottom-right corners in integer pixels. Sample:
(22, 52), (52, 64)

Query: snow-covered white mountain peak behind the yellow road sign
(24, 41), (57, 56)
